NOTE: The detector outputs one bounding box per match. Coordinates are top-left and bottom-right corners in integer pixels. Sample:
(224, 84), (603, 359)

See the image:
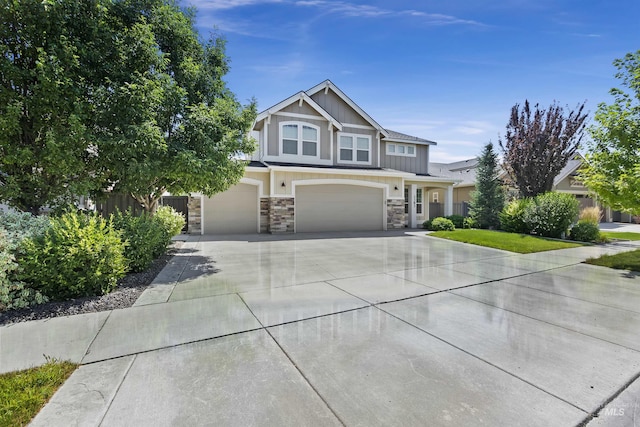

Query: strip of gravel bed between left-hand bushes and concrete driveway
(0, 241), (182, 325)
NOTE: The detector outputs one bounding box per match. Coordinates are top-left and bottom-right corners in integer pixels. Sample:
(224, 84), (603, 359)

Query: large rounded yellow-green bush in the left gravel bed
(18, 212), (127, 300)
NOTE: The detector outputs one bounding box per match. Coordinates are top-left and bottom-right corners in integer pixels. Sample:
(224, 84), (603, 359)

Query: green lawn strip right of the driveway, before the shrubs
(429, 229), (581, 254)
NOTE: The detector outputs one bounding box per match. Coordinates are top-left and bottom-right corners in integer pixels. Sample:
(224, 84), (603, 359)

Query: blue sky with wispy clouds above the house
(182, 0), (640, 162)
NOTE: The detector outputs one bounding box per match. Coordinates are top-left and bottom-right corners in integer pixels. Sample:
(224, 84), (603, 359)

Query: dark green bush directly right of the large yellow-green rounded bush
(112, 210), (167, 272)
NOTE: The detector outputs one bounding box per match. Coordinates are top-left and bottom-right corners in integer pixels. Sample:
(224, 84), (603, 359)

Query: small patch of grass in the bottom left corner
(0, 360), (77, 426)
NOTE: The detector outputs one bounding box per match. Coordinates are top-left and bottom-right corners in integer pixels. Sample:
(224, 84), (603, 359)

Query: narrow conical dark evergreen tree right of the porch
(469, 143), (504, 228)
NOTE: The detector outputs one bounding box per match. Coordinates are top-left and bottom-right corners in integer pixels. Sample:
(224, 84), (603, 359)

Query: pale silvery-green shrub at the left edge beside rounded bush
(0, 211), (49, 311)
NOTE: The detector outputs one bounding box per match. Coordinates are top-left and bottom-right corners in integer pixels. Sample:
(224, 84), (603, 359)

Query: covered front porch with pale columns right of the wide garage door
(404, 176), (458, 228)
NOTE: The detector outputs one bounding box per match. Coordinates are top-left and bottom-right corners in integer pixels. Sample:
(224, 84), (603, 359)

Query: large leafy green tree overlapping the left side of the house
(97, 0), (255, 213)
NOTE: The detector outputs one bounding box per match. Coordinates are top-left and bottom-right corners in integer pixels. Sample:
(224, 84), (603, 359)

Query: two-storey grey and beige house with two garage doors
(189, 80), (458, 234)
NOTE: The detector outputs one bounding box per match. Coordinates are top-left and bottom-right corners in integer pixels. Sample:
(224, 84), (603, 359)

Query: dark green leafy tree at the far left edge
(0, 0), (108, 214)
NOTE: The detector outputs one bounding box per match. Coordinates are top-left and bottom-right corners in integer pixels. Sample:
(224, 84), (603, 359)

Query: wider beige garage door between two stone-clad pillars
(295, 184), (385, 233)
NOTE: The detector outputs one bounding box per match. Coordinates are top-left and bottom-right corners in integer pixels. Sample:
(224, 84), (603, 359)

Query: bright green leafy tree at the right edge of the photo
(580, 50), (640, 215)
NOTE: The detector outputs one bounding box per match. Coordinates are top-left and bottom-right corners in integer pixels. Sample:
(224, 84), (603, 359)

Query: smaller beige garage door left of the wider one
(202, 184), (259, 234)
